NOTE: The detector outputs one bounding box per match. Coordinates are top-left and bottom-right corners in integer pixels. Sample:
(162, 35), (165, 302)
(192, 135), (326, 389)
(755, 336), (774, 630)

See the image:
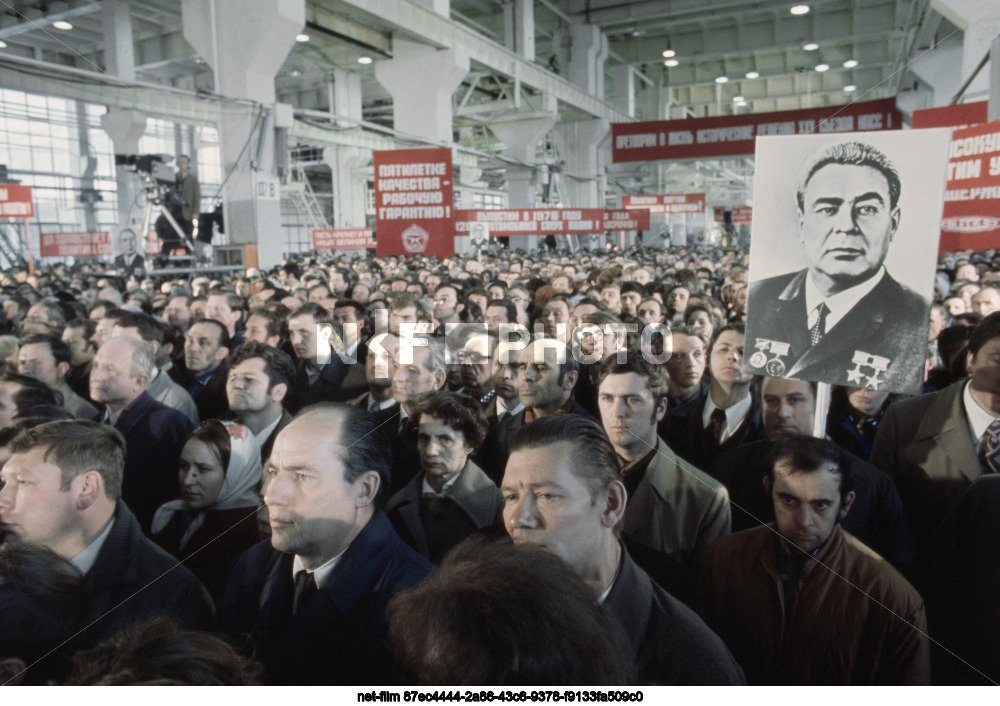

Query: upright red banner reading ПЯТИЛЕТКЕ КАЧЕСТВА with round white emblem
(374, 147), (455, 257)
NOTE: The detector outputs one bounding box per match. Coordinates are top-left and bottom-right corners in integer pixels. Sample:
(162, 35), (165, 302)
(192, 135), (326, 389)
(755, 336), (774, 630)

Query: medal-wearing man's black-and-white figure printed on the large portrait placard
(747, 142), (930, 394)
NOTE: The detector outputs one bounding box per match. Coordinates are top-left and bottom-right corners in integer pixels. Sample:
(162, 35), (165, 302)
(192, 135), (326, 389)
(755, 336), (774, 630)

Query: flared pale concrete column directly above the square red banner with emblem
(375, 37), (469, 143)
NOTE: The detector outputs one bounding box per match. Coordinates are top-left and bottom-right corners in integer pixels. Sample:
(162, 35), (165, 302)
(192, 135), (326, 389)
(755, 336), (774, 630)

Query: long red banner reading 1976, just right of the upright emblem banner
(455, 208), (604, 238)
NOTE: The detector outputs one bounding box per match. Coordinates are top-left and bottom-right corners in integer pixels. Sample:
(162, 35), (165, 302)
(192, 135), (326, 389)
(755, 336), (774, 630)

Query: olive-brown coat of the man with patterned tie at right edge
(871, 381), (983, 549)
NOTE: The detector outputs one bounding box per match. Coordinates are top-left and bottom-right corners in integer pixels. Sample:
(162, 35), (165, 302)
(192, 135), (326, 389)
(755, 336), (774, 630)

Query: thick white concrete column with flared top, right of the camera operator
(182, 0), (306, 267)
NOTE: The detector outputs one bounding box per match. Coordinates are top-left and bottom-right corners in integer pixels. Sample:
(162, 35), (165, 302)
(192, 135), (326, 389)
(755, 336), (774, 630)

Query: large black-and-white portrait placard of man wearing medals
(744, 130), (949, 394)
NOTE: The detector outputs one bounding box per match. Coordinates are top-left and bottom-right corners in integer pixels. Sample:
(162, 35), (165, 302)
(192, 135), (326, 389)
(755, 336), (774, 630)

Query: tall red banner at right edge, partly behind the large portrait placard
(938, 122), (1000, 252)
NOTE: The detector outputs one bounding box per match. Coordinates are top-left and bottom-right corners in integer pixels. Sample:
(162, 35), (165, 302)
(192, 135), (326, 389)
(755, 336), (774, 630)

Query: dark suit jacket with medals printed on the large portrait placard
(745, 270), (930, 394)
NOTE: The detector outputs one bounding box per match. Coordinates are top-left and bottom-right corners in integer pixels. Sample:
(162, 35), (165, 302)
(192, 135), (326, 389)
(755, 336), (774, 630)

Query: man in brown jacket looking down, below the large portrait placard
(701, 436), (930, 685)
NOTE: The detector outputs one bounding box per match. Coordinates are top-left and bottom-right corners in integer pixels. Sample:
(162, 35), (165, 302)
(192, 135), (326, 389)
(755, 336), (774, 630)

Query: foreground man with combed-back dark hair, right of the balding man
(501, 414), (744, 685)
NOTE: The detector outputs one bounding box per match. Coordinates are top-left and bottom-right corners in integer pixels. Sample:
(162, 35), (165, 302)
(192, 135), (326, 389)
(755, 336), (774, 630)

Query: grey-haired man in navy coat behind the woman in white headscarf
(90, 336), (194, 532)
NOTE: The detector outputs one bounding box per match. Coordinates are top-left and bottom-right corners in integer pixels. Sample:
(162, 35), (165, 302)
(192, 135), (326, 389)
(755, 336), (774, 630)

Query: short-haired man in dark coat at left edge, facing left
(0, 421), (212, 639)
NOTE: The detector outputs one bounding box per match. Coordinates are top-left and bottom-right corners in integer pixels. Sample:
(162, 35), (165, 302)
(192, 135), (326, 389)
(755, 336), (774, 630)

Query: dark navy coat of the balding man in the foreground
(218, 512), (430, 685)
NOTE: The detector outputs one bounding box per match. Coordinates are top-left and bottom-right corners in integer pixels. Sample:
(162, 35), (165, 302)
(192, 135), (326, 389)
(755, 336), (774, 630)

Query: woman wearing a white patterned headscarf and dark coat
(152, 419), (261, 598)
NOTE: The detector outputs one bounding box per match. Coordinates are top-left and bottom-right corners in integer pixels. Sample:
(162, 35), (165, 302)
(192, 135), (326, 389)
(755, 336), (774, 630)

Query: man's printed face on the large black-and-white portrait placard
(799, 164), (899, 281)
